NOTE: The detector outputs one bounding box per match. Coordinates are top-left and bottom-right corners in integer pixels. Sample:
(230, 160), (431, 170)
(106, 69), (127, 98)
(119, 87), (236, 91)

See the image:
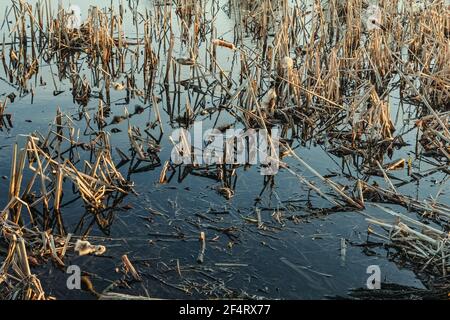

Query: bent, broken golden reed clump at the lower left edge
(0, 111), (131, 299)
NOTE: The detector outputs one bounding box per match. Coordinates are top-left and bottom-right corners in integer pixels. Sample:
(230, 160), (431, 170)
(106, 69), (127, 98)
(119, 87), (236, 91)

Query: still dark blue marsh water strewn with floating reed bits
(0, 0), (450, 299)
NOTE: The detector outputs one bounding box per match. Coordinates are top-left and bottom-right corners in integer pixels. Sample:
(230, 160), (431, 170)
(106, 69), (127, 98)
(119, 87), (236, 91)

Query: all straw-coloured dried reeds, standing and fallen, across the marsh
(0, 0), (450, 299)
